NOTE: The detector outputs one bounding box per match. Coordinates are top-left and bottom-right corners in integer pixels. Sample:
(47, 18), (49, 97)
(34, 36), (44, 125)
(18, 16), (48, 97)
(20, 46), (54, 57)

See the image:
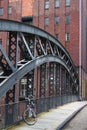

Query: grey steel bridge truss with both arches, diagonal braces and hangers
(0, 19), (79, 97)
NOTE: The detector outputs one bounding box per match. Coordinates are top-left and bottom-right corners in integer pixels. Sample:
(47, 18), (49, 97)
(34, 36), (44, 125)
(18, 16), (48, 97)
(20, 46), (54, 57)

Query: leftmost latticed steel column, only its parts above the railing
(6, 32), (18, 104)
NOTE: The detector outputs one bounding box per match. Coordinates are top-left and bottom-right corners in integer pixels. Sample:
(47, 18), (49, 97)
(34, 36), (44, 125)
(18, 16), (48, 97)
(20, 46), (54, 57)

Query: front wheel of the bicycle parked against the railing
(22, 108), (36, 125)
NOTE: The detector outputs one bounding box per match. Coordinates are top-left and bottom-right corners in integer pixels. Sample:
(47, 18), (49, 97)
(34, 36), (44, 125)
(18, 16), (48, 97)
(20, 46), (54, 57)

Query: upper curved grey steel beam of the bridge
(0, 19), (74, 67)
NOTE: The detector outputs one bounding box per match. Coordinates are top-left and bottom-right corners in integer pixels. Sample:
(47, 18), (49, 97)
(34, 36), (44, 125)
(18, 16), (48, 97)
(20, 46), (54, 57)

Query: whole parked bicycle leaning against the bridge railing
(22, 96), (37, 125)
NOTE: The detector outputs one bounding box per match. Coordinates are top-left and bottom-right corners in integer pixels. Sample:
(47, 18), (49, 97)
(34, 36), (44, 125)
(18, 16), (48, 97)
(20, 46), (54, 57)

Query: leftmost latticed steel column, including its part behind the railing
(5, 32), (18, 126)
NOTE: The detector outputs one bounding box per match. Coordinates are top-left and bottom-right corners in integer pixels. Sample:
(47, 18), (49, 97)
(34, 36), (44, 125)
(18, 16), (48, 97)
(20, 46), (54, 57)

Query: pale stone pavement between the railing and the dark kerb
(7, 101), (87, 130)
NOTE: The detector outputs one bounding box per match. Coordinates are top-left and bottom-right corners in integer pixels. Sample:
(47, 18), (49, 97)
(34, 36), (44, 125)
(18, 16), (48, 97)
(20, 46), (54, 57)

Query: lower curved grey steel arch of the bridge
(0, 56), (72, 97)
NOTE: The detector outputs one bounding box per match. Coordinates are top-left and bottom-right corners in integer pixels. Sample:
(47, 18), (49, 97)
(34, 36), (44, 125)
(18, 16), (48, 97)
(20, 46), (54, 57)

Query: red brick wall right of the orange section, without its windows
(33, 0), (79, 65)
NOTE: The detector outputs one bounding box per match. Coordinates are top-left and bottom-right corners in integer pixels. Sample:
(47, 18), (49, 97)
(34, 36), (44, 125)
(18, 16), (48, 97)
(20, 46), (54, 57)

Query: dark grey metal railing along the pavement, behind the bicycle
(0, 95), (79, 129)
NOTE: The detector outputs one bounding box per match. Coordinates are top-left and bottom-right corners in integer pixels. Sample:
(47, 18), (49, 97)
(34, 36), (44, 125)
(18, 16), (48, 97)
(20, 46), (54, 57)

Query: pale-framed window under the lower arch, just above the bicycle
(20, 79), (27, 96)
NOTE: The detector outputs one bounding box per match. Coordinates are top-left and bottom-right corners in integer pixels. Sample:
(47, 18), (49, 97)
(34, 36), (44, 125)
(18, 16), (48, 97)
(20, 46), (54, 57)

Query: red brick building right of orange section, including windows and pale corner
(33, 0), (87, 98)
